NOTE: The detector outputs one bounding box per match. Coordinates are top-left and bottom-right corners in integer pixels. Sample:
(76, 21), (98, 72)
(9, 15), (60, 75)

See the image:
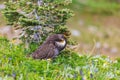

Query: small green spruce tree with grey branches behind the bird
(3, 0), (73, 44)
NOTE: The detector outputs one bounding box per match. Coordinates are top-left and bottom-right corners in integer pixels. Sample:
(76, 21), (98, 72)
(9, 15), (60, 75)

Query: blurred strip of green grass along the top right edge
(70, 0), (120, 15)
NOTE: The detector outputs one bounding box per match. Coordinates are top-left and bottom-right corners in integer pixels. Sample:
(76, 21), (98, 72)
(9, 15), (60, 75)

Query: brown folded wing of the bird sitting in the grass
(33, 43), (55, 59)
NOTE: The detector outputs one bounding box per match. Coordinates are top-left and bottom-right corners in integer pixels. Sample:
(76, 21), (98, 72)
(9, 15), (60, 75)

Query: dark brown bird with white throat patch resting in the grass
(32, 34), (67, 59)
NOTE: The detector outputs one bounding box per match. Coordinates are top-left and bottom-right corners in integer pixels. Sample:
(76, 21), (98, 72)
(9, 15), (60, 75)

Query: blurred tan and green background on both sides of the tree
(0, 0), (120, 58)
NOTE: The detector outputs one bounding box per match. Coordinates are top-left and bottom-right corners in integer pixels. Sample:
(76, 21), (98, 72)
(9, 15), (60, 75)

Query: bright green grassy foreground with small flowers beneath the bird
(0, 38), (120, 80)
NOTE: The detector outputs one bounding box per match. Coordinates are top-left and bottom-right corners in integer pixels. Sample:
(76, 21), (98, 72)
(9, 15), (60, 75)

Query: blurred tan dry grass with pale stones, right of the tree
(67, 12), (120, 58)
